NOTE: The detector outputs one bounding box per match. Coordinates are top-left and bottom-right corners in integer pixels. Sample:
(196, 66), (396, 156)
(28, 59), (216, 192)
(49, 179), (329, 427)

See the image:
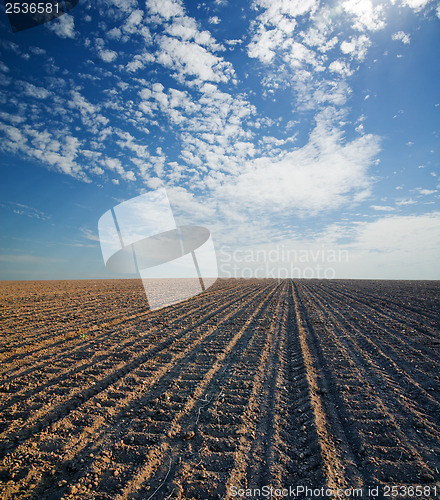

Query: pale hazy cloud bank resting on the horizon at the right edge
(290, 212), (440, 280)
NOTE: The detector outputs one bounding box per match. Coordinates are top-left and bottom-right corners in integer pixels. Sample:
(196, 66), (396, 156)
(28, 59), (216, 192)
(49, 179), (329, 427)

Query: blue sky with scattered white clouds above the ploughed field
(0, 0), (440, 279)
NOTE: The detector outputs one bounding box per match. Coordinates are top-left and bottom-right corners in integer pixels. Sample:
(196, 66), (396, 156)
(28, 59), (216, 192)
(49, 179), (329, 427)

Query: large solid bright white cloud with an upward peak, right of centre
(206, 110), (379, 215)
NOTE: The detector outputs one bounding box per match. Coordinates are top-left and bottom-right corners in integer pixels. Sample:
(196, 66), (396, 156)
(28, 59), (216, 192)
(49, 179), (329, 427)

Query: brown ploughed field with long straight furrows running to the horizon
(0, 280), (440, 500)
